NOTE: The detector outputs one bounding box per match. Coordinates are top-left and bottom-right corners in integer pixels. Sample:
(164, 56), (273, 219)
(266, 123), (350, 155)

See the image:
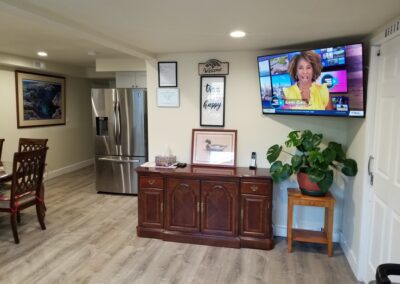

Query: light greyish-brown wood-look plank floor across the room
(0, 167), (357, 284)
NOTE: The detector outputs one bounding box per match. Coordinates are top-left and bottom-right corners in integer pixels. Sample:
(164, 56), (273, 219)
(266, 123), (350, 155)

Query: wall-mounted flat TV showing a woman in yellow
(258, 43), (365, 117)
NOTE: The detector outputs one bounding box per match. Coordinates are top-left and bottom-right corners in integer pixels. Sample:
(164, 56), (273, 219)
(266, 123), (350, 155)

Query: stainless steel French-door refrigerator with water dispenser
(92, 89), (148, 194)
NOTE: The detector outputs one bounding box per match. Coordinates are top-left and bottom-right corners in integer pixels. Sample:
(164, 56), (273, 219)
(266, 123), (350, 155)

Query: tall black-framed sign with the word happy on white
(200, 76), (225, 127)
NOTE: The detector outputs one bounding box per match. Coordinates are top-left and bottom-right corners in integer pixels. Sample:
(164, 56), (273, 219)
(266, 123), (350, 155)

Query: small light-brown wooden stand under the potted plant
(287, 188), (335, 256)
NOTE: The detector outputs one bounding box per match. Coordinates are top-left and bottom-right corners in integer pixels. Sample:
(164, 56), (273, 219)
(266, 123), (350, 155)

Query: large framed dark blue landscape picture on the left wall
(15, 71), (65, 128)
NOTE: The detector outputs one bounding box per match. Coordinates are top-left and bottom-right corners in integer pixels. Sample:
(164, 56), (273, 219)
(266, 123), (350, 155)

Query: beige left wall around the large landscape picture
(0, 69), (94, 177)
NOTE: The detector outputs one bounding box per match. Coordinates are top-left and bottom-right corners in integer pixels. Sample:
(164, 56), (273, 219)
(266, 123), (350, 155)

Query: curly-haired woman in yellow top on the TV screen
(283, 51), (333, 110)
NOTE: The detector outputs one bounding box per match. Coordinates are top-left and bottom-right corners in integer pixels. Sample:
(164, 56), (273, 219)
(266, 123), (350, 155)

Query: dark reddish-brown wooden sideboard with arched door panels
(136, 165), (274, 249)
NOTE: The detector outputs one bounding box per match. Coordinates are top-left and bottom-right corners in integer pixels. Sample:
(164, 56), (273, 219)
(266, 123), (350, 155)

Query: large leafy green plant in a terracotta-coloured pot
(267, 130), (357, 196)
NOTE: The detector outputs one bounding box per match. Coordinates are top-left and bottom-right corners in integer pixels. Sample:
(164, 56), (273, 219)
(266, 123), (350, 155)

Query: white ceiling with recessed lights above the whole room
(0, 0), (400, 67)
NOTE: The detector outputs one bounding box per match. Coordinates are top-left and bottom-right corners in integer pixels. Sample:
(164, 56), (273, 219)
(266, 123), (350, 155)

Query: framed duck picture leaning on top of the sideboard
(192, 129), (237, 167)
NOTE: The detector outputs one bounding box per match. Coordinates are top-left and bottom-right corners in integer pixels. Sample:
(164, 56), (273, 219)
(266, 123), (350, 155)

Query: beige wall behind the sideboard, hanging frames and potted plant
(147, 52), (349, 240)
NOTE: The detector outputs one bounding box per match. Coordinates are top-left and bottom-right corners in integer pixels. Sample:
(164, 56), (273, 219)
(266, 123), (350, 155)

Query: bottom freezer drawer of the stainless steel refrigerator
(95, 156), (147, 194)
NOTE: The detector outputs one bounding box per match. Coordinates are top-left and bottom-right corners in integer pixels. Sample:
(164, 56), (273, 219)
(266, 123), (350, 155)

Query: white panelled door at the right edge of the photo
(365, 34), (400, 282)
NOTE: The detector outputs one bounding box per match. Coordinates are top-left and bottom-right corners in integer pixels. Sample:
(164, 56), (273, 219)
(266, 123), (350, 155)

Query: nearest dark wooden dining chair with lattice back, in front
(0, 147), (48, 244)
